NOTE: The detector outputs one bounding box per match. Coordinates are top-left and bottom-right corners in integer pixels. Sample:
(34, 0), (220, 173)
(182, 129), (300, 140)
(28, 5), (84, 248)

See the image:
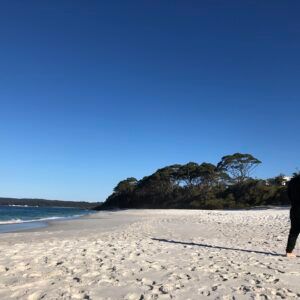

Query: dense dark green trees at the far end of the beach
(97, 153), (289, 210)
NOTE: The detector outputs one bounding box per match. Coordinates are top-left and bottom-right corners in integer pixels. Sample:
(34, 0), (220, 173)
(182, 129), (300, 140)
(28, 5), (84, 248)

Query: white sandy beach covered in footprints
(0, 209), (300, 300)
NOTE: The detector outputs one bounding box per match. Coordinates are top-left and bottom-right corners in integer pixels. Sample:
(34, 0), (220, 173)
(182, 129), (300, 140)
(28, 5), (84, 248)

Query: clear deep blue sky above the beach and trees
(0, 0), (300, 201)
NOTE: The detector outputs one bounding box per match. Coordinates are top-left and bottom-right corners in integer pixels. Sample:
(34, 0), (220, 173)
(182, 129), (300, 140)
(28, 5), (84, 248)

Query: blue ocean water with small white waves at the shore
(0, 205), (91, 232)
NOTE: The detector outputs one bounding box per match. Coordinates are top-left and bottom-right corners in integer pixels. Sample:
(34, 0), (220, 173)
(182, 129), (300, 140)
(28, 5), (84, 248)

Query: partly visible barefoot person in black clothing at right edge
(286, 174), (300, 257)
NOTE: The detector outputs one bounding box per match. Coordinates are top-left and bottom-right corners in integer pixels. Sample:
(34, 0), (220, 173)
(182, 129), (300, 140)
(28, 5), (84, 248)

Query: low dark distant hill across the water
(0, 197), (101, 209)
